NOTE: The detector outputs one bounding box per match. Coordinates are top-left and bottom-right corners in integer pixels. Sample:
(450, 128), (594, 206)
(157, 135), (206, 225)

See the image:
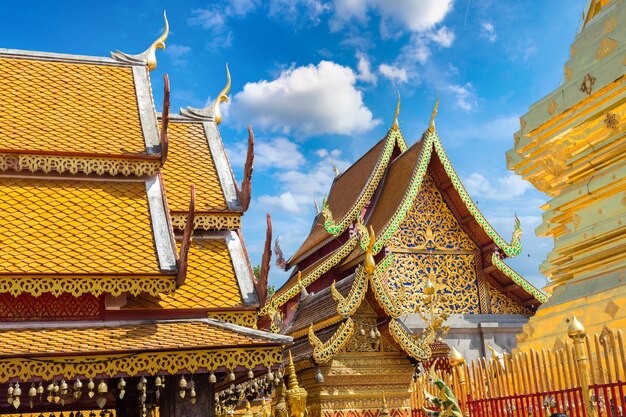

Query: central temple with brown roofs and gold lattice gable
(260, 100), (546, 417)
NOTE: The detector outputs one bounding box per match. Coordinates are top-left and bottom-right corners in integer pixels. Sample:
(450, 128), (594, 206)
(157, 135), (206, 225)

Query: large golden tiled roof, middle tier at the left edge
(0, 178), (159, 274)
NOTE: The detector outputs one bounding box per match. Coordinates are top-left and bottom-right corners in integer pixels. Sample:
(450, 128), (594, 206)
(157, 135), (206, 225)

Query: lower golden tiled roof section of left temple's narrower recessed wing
(125, 238), (243, 309)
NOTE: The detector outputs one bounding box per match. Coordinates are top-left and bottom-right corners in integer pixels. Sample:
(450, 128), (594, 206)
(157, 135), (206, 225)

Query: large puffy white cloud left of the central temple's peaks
(231, 61), (380, 137)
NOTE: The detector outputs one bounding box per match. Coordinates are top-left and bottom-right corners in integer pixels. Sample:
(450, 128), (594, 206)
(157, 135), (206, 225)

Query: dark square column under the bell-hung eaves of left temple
(159, 375), (215, 417)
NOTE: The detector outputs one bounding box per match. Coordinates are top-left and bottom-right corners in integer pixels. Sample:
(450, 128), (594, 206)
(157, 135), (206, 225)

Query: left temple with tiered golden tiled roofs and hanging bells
(0, 13), (291, 417)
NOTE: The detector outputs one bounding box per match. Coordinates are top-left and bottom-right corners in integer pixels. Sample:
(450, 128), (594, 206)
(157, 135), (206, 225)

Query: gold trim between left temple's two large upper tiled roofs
(0, 154), (161, 177)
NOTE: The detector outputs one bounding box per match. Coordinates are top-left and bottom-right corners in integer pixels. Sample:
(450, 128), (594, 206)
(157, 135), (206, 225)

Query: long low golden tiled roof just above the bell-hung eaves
(0, 319), (271, 359)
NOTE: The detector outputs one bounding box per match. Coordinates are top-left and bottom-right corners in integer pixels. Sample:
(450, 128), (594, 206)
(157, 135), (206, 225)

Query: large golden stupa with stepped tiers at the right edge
(506, 0), (626, 350)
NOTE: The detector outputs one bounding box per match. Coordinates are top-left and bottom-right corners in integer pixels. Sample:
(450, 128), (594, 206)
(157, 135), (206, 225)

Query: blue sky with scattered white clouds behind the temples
(0, 0), (585, 287)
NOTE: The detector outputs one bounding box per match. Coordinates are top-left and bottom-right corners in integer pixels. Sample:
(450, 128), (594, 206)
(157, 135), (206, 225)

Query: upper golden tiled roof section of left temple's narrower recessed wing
(162, 120), (228, 212)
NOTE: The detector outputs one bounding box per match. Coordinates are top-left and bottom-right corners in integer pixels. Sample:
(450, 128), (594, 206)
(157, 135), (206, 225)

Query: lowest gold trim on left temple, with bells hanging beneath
(0, 346), (282, 383)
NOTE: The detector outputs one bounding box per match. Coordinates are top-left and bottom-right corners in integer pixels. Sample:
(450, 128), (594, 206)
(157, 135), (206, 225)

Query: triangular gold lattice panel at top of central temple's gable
(387, 174), (477, 250)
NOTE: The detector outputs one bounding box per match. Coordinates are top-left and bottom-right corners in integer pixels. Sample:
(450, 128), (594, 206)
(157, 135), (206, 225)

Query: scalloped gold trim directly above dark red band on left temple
(0, 276), (176, 297)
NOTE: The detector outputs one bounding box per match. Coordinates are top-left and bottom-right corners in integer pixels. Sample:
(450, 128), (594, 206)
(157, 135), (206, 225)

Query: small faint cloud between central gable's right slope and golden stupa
(463, 172), (532, 201)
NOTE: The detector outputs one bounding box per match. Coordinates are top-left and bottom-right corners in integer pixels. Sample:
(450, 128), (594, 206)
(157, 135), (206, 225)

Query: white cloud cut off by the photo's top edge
(331, 0), (453, 32)
